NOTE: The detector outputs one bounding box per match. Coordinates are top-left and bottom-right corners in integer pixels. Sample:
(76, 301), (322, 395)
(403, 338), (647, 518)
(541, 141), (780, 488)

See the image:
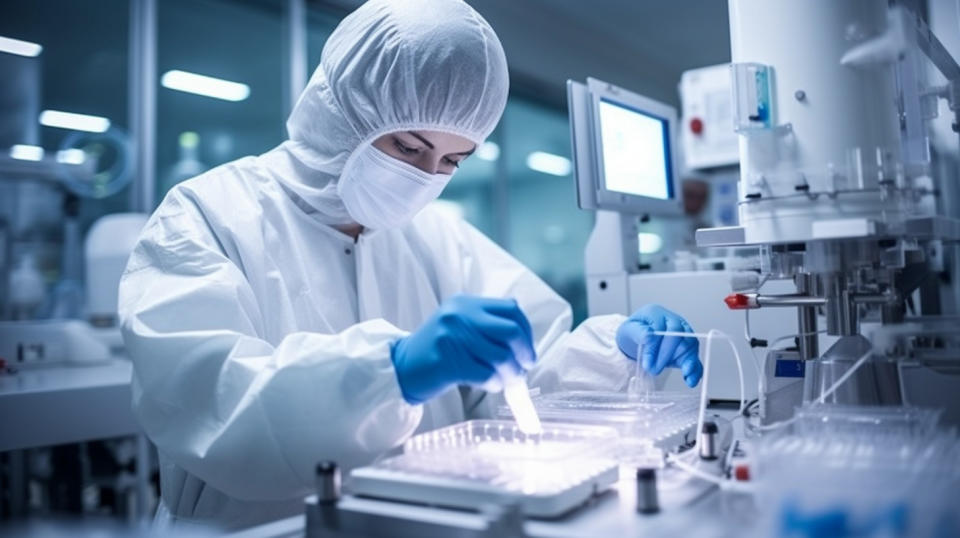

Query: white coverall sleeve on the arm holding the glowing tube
(119, 192), (423, 501)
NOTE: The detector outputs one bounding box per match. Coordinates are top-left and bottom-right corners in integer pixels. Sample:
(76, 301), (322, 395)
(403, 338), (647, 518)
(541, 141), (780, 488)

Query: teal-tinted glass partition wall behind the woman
(0, 0), (593, 320)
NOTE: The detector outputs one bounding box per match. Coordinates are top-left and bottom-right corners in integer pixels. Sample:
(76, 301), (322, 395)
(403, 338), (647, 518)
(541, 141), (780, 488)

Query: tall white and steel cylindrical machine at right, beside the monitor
(697, 0), (960, 420)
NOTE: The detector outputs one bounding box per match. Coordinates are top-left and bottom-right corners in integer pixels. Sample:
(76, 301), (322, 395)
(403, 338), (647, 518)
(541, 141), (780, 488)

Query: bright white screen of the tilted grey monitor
(599, 99), (674, 200)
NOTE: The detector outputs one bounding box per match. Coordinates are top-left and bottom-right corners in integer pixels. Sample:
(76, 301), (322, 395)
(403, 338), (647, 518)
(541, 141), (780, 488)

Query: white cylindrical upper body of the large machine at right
(729, 0), (904, 243)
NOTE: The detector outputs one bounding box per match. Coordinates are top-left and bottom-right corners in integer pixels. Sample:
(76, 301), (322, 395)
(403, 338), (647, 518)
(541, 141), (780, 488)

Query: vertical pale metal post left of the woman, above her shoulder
(128, 0), (157, 213)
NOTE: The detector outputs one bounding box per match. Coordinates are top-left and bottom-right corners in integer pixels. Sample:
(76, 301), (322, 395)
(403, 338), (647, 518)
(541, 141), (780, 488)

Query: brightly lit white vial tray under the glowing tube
(350, 420), (618, 517)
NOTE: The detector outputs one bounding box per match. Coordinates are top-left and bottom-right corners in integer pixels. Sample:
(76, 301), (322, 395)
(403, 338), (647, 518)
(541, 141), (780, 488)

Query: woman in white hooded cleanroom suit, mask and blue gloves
(119, 0), (700, 528)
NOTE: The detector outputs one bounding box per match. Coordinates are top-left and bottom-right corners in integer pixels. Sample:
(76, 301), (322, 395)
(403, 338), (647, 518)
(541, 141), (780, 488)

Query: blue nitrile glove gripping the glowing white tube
(390, 295), (536, 404)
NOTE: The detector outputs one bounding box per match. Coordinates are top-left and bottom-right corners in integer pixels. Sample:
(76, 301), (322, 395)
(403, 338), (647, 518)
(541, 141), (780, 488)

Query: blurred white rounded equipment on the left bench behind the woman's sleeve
(84, 213), (149, 325)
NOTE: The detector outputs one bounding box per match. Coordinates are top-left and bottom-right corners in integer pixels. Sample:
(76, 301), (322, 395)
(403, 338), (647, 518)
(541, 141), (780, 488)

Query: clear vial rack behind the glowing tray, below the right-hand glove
(498, 391), (700, 466)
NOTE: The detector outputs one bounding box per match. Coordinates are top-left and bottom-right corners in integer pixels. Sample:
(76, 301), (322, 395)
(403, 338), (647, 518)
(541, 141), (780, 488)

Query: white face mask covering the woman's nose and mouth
(337, 145), (453, 230)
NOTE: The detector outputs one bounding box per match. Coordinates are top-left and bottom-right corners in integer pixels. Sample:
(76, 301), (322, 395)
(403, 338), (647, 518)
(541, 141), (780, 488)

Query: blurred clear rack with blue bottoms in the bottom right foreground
(756, 405), (960, 536)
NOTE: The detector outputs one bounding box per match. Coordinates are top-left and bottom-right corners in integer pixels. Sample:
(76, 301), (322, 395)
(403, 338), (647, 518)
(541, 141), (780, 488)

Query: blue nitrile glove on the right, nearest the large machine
(617, 304), (703, 387)
